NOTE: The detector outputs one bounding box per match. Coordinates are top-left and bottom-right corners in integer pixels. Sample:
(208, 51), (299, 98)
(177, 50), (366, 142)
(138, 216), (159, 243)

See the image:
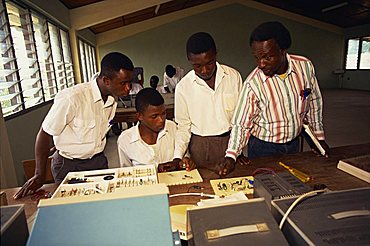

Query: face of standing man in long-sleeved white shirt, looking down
(188, 50), (217, 81)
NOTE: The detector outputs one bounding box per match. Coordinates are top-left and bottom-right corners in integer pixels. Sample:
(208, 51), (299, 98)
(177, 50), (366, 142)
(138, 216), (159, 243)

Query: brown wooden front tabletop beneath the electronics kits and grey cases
(3, 143), (370, 218)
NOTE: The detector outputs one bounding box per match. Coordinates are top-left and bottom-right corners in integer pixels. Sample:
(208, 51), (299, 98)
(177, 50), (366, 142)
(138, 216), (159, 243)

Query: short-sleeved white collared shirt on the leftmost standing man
(42, 74), (117, 159)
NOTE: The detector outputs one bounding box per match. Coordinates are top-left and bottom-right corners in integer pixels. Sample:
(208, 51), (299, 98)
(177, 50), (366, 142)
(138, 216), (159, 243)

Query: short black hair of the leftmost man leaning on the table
(99, 52), (134, 79)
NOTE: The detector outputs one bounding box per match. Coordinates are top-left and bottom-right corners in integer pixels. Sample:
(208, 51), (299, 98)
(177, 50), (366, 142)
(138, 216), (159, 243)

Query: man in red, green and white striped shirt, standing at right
(219, 22), (329, 175)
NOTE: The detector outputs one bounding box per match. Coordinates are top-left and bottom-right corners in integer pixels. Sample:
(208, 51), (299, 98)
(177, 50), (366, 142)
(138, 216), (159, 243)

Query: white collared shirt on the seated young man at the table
(117, 120), (177, 167)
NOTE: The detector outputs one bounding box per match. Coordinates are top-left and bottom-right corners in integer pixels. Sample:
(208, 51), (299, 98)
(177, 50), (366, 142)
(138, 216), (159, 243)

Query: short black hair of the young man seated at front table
(135, 87), (164, 113)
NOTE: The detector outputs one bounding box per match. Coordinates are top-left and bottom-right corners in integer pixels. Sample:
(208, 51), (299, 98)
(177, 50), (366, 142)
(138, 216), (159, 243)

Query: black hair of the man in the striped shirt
(249, 21), (292, 49)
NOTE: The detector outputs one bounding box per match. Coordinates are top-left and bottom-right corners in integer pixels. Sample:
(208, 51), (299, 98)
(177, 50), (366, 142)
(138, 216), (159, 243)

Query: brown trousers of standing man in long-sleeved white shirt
(189, 132), (230, 169)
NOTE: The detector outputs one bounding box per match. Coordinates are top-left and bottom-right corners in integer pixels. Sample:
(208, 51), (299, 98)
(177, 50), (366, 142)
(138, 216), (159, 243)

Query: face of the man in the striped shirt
(252, 39), (288, 77)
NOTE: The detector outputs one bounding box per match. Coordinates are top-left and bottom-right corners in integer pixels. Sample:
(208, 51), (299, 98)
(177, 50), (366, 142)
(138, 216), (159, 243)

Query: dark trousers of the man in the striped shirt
(248, 135), (299, 159)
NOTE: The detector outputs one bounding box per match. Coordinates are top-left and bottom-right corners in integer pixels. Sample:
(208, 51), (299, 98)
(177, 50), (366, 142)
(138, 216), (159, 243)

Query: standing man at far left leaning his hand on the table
(14, 52), (133, 198)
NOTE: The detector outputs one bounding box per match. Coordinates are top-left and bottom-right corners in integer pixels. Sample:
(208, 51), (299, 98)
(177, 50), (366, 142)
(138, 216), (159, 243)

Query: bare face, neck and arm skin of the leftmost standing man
(13, 69), (133, 199)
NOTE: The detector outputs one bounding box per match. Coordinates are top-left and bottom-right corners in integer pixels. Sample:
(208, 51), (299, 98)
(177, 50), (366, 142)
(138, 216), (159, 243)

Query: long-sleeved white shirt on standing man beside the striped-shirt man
(174, 62), (242, 158)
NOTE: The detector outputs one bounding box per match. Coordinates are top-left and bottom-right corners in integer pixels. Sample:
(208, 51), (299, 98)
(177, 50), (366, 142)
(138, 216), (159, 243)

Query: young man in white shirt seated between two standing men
(117, 88), (195, 172)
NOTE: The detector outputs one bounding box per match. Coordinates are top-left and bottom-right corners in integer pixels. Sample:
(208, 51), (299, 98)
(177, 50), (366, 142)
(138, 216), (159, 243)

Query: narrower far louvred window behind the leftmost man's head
(78, 39), (97, 82)
